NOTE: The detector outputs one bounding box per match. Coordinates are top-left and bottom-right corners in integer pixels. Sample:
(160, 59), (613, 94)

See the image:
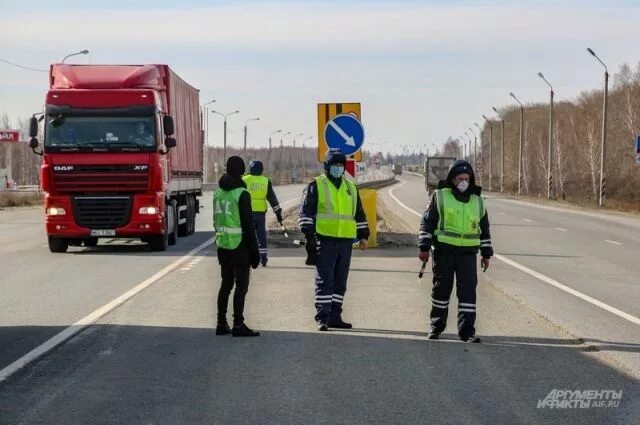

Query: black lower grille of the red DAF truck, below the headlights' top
(73, 196), (132, 229)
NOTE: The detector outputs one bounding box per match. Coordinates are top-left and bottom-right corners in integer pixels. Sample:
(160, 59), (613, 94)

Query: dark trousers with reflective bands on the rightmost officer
(431, 248), (478, 338)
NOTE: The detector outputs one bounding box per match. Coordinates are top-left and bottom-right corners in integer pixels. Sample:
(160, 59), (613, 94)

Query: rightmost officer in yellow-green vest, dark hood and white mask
(418, 160), (493, 342)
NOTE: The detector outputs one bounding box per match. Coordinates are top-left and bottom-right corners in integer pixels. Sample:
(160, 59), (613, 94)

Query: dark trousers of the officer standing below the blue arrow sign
(315, 236), (353, 323)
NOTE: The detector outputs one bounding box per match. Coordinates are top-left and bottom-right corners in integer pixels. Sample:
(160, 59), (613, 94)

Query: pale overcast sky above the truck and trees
(0, 0), (640, 153)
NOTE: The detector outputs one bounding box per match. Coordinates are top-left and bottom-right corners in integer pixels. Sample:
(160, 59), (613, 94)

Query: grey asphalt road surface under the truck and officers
(0, 176), (640, 424)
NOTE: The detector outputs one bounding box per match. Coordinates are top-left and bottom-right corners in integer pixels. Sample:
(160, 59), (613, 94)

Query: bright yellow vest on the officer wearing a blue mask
(316, 174), (358, 239)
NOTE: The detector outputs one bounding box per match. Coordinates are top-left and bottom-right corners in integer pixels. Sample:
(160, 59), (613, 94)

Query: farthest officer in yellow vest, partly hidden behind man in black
(243, 160), (282, 267)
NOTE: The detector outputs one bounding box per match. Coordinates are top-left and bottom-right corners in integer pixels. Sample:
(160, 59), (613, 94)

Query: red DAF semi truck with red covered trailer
(29, 64), (204, 252)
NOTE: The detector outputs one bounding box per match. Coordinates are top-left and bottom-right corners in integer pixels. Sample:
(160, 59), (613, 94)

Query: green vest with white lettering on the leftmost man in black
(213, 187), (245, 249)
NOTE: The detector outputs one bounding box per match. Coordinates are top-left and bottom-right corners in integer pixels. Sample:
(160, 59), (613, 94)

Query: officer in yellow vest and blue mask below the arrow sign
(298, 149), (369, 331)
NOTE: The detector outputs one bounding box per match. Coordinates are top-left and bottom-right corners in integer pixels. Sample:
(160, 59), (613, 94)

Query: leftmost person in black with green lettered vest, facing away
(213, 156), (260, 336)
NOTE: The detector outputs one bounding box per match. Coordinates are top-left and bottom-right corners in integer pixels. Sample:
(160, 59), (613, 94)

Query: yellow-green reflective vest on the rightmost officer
(435, 188), (485, 247)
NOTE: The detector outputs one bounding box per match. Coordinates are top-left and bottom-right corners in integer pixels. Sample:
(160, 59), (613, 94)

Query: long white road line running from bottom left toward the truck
(0, 238), (214, 382)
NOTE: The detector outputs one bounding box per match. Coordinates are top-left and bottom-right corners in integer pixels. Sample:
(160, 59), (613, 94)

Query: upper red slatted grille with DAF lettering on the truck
(53, 164), (149, 193)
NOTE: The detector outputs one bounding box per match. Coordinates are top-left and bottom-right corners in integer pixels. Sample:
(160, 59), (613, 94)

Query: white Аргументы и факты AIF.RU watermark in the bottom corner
(538, 389), (622, 409)
